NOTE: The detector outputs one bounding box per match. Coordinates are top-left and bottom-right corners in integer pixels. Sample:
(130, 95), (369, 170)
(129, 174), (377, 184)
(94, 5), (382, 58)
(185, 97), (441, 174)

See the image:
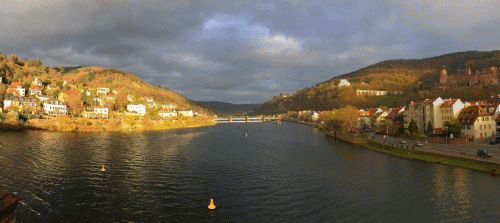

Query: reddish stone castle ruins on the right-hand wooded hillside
(439, 67), (500, 86)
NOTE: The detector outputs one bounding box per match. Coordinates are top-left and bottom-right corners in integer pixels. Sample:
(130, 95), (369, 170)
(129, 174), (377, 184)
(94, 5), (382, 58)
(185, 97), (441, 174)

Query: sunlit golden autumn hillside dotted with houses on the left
(0, 54), (208, 114)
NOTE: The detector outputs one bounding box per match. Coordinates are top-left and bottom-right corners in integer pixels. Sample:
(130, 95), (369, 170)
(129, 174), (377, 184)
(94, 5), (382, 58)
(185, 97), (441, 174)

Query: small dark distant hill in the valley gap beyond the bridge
(193, 101), (258, 115)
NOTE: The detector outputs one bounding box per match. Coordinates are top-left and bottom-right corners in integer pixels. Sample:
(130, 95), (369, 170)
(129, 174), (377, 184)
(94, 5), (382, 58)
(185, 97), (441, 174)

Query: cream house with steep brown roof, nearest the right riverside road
(458, 105), (496, 141)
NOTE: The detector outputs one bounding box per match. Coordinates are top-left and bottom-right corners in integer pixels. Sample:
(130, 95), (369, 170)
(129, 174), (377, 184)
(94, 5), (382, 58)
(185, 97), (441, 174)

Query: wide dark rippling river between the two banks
(0, 123), (500, 222)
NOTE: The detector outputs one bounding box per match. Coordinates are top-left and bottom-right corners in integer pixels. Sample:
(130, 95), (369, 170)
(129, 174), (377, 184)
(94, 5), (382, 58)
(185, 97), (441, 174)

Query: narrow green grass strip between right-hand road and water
(357, 143), (500, 175)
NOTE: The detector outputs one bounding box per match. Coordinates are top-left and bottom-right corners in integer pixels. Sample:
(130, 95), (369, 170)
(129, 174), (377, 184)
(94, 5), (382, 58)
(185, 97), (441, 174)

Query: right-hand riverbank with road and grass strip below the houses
(325, 132), (500, 176)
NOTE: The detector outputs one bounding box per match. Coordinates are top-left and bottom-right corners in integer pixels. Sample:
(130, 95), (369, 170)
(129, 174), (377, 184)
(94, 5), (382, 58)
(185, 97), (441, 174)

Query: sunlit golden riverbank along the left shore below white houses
(22, 116), (216, 132)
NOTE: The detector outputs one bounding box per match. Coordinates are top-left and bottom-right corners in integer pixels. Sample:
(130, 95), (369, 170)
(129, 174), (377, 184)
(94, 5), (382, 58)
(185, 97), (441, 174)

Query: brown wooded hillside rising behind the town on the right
(256, 50), (500, 113)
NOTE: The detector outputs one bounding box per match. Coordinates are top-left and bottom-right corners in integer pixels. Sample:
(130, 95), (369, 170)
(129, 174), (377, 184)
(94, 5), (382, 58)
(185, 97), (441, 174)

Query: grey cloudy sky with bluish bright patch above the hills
(0, 0), (500, 104)
